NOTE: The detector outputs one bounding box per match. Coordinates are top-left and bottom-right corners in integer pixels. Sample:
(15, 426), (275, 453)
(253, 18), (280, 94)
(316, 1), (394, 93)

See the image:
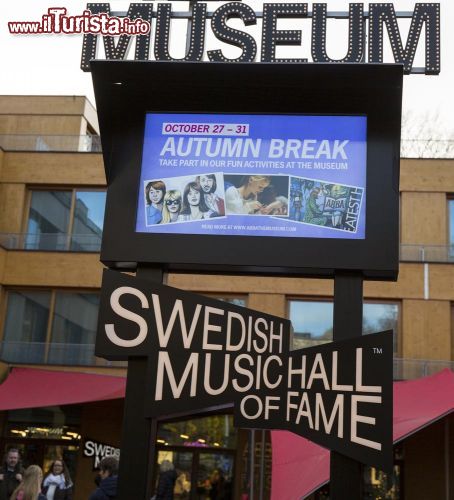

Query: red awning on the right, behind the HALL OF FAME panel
(271, 369), (454, 500)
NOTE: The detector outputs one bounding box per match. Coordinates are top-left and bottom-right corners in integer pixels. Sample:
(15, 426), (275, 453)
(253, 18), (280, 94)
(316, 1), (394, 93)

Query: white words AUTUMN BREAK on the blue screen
(160, 137), (350, 160)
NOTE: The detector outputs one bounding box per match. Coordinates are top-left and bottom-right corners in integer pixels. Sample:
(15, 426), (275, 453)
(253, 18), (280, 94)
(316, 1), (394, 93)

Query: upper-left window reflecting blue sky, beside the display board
(24, 189), (106, 252)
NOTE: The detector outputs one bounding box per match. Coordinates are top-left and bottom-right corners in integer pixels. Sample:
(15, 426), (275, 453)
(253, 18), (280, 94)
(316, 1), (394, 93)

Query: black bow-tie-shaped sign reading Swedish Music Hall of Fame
(96, 271), (393, 470)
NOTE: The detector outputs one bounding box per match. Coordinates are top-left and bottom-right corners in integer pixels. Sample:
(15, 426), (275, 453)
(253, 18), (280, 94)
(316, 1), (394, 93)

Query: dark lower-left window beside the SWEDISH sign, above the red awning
(0, 290), (99, 365)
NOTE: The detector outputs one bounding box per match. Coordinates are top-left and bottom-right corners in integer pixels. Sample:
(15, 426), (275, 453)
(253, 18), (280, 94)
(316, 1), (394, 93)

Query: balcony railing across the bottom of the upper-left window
(0, 233), (102, 252)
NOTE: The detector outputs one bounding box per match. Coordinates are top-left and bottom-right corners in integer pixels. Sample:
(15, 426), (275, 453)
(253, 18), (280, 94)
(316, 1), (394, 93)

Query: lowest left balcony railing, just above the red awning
(0, 341), (127, 367)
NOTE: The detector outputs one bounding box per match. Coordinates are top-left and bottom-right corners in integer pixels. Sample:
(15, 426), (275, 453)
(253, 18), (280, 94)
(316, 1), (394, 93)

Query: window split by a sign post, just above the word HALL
(289, 300), (399, 354)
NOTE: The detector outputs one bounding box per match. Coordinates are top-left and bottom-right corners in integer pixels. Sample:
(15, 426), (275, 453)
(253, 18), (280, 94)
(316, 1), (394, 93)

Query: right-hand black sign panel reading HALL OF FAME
(235, 331), (393, 471)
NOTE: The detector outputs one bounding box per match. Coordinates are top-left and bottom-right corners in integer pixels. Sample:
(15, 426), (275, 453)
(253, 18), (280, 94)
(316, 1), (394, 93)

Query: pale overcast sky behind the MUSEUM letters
(0, 0), (454, 139)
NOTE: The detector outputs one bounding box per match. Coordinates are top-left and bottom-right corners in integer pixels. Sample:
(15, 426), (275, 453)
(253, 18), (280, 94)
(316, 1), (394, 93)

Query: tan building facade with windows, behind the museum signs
(0, 96), (454, 500)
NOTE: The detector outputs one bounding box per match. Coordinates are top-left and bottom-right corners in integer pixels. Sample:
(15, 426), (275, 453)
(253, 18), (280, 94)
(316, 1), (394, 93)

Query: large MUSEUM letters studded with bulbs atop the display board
(81, 2), (440, 75)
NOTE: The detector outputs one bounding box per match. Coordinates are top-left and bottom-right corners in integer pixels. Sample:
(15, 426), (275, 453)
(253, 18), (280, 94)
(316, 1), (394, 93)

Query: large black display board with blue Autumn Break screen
(92, 61), (403, 279)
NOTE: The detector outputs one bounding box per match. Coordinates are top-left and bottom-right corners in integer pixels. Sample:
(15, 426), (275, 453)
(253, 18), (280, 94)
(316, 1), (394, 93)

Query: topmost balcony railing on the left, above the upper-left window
(0, 134), (102, 153)
